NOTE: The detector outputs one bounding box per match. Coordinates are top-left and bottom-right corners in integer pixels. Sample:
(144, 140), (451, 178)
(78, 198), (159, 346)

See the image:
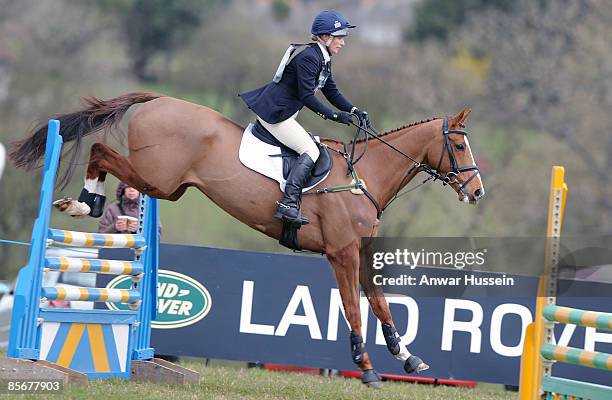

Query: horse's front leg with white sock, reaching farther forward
(359, 243), (429, 374)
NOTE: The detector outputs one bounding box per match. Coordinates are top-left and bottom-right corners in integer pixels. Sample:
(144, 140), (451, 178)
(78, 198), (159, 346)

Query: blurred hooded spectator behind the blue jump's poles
(98, 182), (161, 234)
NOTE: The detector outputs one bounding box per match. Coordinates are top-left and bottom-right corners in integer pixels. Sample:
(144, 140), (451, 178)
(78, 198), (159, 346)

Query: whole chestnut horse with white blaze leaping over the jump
(11, 93), (484, 387)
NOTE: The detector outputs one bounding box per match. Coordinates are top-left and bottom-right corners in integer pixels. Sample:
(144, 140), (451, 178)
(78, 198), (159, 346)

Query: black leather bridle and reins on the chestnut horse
(347, 114), (480, 210)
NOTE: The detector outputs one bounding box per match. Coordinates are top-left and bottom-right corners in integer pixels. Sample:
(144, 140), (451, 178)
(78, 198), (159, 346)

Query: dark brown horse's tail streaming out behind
(10, 93), (162, 188)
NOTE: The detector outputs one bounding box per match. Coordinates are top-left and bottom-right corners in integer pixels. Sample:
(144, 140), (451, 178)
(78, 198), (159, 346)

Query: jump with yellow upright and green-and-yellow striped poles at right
(519, 166), (612, 400)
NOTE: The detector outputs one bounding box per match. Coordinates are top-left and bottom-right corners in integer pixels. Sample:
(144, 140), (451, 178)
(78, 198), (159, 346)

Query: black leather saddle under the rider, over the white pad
(252, 121), (333, 188)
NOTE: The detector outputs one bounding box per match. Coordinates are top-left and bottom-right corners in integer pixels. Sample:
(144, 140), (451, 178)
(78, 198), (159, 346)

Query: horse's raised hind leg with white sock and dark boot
(54, 143), (172, 218)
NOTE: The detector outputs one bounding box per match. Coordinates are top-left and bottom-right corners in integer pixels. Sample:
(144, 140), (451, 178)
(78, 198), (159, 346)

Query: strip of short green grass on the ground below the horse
(0, 361), (516, 400)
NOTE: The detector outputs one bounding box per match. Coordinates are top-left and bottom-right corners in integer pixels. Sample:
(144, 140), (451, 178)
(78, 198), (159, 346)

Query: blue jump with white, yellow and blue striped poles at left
(0, 120), (198, 383)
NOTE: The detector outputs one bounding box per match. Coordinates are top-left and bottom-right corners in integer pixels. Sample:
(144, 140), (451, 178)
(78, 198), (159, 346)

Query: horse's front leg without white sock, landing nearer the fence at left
(327, 241), (381, 388)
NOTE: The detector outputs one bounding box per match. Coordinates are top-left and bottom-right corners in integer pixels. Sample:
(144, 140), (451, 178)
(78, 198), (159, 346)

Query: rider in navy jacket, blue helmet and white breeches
(240, 11), (367, 224)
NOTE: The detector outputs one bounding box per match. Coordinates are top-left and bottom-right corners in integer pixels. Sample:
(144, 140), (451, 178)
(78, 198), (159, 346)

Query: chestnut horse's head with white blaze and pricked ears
(427, 108), (485, 204)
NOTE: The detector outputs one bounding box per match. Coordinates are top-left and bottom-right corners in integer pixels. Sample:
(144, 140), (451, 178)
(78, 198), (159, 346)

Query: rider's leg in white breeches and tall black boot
(259, 113), (319, 224)
